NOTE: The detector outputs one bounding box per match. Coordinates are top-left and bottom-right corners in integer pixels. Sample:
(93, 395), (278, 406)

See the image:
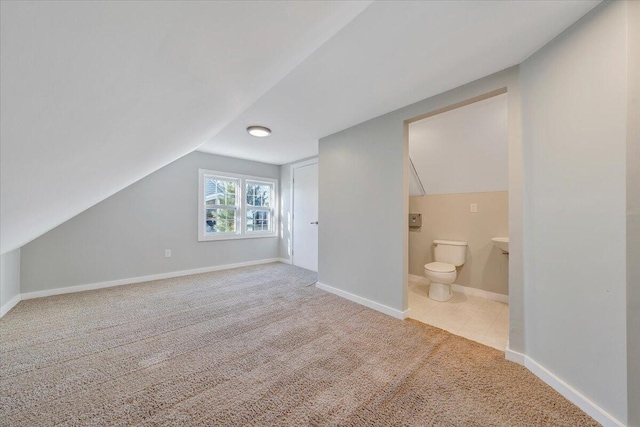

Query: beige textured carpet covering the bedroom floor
(0, 264), (598, 426)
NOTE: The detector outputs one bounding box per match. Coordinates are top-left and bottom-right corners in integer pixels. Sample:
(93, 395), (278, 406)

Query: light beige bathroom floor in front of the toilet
(409, 282), (509, 351)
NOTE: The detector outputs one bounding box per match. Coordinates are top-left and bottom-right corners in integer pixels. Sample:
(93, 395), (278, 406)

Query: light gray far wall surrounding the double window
(21, 152), (280, 292)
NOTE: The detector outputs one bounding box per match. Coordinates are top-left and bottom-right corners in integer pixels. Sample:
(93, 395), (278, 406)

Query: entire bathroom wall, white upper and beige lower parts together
(409, 93), (509, 295)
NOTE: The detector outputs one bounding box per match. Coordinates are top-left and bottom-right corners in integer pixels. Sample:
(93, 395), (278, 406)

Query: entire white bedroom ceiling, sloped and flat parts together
(0, 0), (598, 253)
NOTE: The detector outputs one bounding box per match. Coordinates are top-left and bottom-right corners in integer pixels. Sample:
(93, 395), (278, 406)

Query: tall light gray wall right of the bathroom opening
(520, 2), (637, 423)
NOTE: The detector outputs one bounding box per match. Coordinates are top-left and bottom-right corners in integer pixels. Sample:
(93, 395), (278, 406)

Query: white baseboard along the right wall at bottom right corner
(524, 352), (624, 427)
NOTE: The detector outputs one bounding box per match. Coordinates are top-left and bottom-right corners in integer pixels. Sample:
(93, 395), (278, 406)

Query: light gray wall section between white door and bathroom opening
(318, 115), (408, 311)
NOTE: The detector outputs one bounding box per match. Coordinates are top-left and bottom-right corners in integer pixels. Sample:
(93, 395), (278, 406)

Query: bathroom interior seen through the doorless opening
(408, 93), (509, 351)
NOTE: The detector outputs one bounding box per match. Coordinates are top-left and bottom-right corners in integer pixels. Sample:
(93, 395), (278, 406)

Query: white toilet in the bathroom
(424, 240), (467, 301)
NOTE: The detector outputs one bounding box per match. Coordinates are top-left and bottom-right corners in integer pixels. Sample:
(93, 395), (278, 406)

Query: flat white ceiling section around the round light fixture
(199, 0), (599, 164)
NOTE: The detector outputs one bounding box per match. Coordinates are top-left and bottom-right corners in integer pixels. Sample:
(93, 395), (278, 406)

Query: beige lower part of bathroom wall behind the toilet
(409, 191), (509, 295)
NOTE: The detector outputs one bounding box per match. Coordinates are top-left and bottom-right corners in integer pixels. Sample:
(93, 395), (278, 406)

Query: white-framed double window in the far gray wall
(198, 169), (278, 241)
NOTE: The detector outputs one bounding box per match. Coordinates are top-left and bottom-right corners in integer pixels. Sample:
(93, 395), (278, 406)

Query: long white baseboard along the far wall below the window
(21, 258), (287, 300)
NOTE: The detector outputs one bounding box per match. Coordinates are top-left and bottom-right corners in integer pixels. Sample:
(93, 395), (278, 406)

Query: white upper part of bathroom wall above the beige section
(409, 94), (509, 196)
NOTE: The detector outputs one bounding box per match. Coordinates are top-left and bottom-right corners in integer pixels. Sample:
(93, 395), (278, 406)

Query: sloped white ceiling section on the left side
(0, 1), (368, 253)
